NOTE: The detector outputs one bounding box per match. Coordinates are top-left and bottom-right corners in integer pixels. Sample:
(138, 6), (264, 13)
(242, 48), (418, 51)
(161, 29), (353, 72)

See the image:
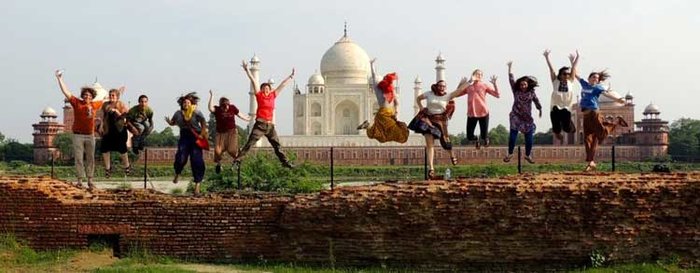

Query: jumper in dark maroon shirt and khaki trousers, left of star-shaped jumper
(209, 90), (250, 173)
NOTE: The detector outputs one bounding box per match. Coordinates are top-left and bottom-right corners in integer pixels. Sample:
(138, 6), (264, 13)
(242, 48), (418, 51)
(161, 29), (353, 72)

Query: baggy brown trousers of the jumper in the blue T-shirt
(583, 110), (616, 162)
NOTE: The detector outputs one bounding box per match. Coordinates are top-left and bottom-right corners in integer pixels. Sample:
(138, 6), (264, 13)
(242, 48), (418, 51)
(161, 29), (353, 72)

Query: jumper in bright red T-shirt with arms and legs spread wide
(234, 61), (294, 169)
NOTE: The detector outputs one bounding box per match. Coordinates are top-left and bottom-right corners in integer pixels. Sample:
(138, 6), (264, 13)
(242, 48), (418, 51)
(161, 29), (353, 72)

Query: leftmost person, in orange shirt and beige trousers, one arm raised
(56, 70), (102, 190)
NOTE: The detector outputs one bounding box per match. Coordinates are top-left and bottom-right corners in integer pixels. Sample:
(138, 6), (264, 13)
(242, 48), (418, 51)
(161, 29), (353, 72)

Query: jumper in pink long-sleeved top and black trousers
(457, 69), (501, 149)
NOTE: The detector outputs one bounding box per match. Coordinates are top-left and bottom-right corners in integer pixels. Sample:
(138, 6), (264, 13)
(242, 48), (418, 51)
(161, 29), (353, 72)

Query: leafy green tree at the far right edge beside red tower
(668, 118), (700, 161)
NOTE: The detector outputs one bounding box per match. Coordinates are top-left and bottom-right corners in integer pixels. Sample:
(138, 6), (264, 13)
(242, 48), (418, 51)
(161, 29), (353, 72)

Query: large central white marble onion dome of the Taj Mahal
(321, 35), (370, 84)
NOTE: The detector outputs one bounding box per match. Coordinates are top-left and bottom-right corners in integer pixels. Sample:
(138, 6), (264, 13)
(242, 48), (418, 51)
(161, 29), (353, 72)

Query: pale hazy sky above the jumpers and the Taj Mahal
(0, 0), (700, 142)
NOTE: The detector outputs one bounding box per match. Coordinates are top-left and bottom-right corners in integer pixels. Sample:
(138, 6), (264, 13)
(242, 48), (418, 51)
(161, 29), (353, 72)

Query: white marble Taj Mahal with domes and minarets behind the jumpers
(249, 31), (432, 147)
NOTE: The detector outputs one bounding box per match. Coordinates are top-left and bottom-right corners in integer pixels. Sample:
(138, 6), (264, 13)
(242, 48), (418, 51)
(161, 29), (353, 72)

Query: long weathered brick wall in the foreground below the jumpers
(0, 173), (700, 271)
